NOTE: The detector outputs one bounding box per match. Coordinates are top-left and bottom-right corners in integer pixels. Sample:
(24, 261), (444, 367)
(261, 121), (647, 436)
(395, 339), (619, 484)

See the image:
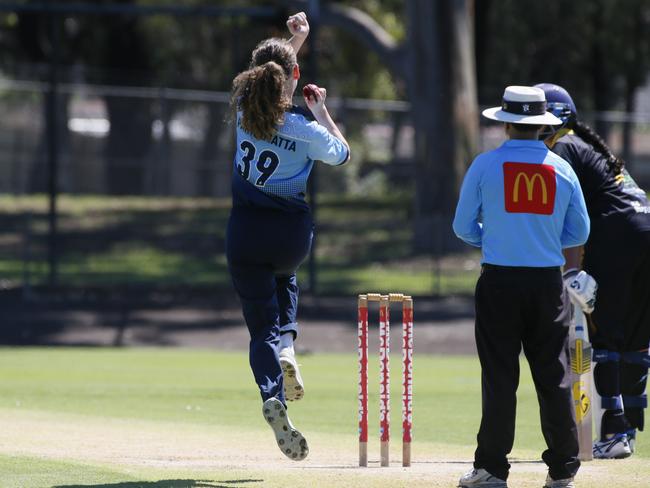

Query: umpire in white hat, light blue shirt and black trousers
(453, 86), (589, 488)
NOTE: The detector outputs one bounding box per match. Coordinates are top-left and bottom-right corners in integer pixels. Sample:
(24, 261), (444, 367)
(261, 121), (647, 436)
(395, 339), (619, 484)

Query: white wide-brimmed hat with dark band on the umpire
(483, 86), (562, 125)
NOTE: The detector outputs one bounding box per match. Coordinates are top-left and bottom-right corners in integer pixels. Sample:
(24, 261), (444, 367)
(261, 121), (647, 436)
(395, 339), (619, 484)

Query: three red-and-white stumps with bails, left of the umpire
(358, 293), (413, 466)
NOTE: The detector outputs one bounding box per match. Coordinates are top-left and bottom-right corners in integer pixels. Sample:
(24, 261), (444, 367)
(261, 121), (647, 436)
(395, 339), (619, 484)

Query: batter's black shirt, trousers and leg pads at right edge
(551, 132), (650, 437)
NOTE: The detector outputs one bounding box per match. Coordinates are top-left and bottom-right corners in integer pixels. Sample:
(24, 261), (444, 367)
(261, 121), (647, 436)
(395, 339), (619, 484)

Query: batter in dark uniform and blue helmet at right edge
(537, 83), (650, 458)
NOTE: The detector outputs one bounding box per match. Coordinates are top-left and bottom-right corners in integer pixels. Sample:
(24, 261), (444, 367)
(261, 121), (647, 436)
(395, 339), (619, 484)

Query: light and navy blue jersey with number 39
(232, 107), (348, 211)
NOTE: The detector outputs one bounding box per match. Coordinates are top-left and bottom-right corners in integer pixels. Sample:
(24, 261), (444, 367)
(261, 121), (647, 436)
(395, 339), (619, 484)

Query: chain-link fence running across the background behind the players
(0, 79), (650, 302)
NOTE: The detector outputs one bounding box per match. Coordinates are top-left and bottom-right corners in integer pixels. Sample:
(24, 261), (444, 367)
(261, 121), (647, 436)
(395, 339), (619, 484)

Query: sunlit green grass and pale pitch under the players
(0, 343), (650, 488)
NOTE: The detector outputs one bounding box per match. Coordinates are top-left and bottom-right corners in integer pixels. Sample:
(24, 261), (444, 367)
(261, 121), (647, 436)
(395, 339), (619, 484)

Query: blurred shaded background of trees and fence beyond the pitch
(0, 0), (650, 344)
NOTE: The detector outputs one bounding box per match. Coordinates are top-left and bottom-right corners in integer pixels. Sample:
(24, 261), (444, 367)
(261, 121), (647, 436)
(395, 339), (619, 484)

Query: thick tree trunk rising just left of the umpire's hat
(407, 0), (478, 252)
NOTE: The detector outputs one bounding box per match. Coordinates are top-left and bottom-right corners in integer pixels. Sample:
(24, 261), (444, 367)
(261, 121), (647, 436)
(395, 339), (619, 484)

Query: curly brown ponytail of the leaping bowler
(231, 61), (291, 140)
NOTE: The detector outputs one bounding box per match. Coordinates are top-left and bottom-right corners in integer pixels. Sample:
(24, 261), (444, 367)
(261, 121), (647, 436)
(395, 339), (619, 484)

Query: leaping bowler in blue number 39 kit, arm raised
(226, 12), (350, 461)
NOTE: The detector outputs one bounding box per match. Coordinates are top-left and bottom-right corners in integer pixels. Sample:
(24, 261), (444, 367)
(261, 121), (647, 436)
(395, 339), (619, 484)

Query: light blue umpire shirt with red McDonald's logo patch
(453, 139), (589, 267)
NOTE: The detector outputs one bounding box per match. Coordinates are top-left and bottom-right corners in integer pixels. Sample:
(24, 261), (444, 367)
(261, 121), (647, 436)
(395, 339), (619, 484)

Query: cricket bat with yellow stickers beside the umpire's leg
(569, 303), (593, 461)
